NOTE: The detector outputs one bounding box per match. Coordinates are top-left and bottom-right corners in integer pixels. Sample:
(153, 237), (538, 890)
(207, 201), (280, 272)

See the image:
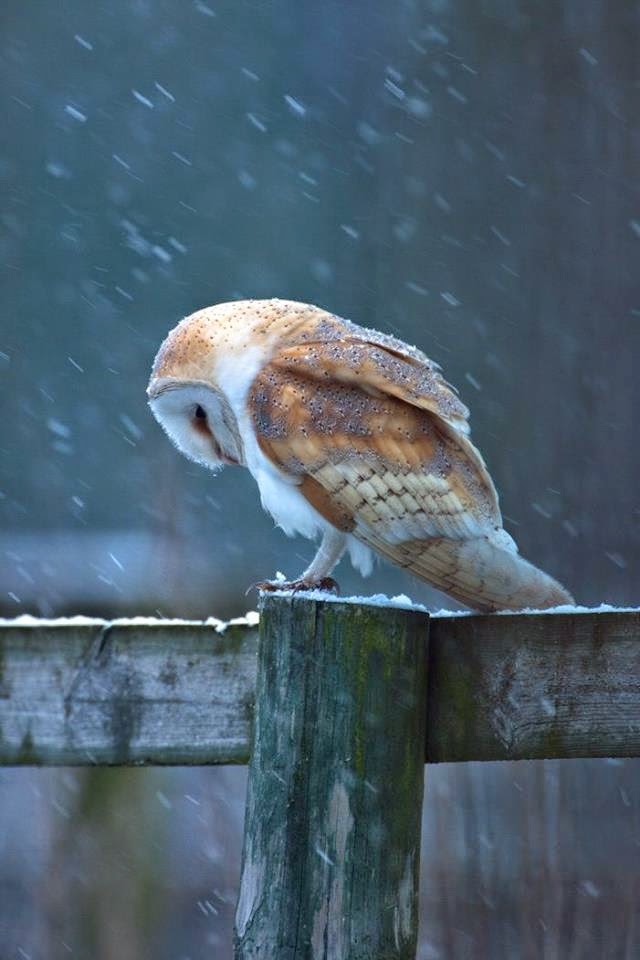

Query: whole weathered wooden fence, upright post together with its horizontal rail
(0, 596), (640, 960)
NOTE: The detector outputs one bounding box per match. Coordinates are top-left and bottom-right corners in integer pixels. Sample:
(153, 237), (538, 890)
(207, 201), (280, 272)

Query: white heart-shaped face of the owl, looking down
(148, 377), (243, 470)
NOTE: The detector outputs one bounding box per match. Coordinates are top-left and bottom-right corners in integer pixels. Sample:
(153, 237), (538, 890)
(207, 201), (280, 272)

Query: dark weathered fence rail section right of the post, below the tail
(427, 612), (640, 763)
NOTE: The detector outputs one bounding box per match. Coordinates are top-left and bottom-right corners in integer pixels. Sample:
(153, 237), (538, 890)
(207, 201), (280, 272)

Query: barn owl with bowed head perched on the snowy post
(147, 300), (571, 611)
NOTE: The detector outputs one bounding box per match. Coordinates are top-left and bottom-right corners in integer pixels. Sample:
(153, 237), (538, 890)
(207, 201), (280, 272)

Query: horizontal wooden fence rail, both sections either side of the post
(0, 600), (640, 765)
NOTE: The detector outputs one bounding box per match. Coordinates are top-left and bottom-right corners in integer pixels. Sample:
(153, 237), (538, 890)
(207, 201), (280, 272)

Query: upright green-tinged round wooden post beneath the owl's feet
(235, 596), (429, 960)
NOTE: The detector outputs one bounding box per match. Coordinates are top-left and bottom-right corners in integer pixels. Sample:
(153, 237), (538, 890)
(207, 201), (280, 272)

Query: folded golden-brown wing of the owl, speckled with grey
(249, 340), (508, 602)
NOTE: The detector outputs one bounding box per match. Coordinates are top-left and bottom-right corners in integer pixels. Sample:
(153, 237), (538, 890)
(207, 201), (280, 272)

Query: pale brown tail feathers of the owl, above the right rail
(388, 530), (574, 613)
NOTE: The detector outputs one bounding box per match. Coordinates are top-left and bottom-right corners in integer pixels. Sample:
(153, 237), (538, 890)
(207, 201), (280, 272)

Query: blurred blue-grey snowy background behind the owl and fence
(0, 0), (640, 960)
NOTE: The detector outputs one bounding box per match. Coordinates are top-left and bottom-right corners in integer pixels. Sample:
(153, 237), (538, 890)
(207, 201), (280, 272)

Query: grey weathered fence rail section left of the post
(0, 621), (258, 764)
